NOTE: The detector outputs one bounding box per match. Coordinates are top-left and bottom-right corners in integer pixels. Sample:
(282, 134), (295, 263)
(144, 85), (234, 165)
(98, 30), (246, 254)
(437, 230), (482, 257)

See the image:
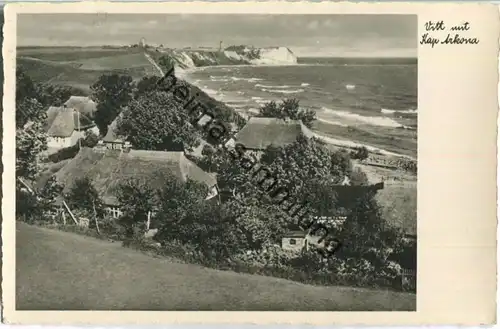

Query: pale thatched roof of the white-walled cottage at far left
(46, 106), (95, 137)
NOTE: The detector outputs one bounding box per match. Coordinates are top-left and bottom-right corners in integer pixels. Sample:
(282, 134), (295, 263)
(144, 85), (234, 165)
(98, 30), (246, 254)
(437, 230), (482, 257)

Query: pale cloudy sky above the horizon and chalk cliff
(17, 14), (418, 57)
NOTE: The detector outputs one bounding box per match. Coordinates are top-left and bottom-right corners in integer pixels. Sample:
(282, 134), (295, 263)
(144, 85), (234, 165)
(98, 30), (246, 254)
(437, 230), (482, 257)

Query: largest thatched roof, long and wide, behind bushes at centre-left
(56, 148), (217, 204)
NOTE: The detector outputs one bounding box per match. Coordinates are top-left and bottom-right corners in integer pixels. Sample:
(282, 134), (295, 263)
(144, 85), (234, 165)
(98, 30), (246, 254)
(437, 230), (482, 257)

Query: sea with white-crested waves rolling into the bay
(186, 58), (418, 158)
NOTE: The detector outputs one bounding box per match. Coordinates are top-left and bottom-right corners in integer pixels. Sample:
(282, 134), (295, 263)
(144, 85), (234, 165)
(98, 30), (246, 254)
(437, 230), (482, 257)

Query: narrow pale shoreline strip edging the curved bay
(175, 64), (417, 160)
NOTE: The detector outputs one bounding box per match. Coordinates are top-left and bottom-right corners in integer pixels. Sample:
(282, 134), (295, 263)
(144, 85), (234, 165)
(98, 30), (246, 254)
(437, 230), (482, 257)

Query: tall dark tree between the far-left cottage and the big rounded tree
(90, 74), (132, 135)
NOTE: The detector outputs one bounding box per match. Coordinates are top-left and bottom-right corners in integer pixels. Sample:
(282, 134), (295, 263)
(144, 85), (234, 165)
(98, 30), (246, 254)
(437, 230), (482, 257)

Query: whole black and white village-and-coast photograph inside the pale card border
(15, 12), (418, 312)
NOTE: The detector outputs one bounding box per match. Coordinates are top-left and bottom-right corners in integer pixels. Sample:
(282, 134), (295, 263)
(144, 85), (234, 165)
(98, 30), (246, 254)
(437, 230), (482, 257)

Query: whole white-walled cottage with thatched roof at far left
(46, 106), (99, 149)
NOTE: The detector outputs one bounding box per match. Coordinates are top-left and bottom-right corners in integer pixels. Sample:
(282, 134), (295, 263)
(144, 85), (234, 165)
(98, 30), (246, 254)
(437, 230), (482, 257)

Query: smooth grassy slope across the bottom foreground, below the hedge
(16, 222), (416, 311)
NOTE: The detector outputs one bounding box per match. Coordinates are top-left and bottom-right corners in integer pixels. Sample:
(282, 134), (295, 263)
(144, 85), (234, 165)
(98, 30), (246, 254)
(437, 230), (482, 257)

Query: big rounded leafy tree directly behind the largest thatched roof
(117, 91), (201, 151)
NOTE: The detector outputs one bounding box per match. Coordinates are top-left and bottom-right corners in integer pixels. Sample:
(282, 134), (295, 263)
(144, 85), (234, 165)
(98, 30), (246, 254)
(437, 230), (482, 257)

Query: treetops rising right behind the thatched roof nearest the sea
(259, 98), (316, 128)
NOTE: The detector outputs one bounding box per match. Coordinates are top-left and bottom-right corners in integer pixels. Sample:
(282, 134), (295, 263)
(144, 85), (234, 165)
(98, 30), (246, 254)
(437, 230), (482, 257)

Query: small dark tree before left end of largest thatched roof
(66, 177), (104, 217)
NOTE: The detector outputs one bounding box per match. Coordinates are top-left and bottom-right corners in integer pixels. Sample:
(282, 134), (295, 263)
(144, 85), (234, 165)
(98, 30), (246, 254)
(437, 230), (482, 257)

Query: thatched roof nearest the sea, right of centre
(235, 117), (312, 150)
